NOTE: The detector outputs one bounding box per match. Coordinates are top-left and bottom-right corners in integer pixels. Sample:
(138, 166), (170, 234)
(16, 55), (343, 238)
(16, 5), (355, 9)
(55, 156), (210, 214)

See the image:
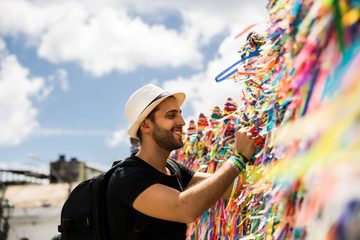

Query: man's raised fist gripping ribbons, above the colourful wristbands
(235, 127), (256, 161)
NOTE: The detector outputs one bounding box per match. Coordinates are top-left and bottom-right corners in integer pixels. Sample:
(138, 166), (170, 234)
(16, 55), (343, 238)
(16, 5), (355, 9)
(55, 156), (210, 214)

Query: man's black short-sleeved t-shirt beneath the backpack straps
(106, 156), (194, 240)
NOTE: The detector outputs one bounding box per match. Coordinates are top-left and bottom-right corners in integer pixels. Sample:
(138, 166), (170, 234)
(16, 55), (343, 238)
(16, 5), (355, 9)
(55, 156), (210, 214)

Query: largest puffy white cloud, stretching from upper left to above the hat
(0, 0), (202, 76)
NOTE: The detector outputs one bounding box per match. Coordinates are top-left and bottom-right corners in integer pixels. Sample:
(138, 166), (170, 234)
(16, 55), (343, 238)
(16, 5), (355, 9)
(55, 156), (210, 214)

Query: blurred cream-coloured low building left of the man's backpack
(5, 183), (77, 240)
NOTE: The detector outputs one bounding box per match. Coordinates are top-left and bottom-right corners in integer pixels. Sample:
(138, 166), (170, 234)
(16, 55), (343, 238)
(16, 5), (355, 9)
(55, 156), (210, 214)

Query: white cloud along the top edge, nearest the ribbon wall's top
(123, 0), (267, 44)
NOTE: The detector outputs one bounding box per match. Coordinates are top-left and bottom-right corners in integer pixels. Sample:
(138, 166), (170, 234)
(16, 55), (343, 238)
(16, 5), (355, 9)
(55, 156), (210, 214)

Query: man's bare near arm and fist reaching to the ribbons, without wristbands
(133, 129), (255, 223)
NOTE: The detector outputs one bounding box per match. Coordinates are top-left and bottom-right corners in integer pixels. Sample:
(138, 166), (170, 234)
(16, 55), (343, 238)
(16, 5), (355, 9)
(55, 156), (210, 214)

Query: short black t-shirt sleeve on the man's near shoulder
(113, 167), (158, 206)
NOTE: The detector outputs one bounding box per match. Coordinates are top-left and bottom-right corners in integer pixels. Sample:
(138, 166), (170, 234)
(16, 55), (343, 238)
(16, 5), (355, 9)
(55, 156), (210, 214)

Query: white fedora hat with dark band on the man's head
(125, 84), (185, 138)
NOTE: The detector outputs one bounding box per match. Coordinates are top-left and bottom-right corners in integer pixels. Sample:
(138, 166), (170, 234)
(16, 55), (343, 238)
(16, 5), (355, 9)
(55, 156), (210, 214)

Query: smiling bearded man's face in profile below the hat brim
(151, 97), (185, 151)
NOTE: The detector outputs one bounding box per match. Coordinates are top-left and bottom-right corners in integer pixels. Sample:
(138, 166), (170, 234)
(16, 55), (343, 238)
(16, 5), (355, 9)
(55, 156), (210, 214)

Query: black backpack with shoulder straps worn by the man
(55, 158), (183, 240)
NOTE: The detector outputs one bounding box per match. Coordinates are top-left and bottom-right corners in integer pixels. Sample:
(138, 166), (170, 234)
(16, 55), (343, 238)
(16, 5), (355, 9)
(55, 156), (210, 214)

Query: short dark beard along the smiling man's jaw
(152, 123), (184, 152)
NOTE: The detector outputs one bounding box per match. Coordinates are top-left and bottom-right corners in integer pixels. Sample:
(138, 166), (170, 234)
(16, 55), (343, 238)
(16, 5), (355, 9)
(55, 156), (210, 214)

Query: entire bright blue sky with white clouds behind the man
(0, 0), (267, 171)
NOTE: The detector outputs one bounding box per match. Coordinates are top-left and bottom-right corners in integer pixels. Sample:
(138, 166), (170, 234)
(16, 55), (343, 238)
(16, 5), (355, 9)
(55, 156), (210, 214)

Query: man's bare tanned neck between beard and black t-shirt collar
(136, 143), (170, 173)
